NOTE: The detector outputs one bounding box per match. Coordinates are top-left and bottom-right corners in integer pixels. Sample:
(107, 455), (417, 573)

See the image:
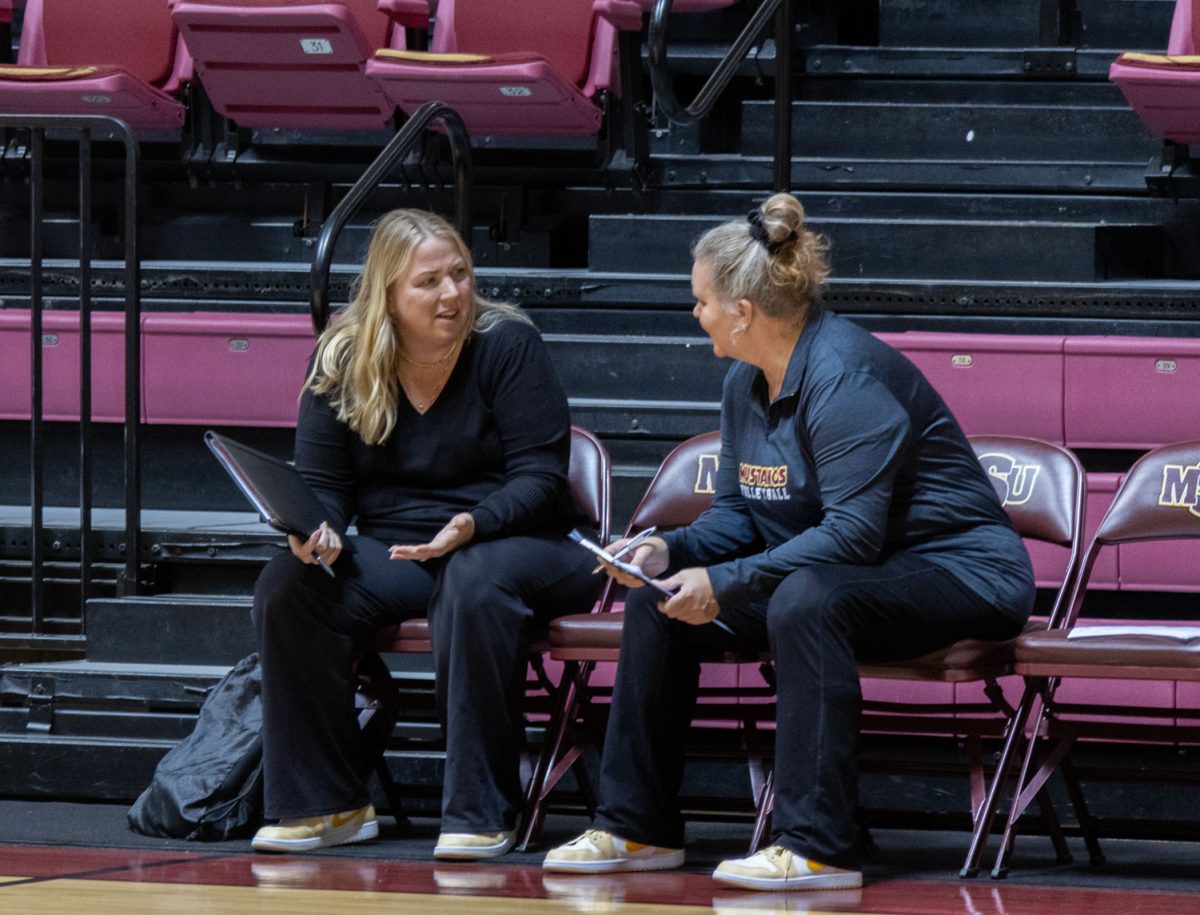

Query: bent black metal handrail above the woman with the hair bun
(647, 0), (796, 191)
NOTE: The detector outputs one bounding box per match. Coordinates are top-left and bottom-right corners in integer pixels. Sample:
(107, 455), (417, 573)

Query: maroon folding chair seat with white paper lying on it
(1016, 626), (1200, 681)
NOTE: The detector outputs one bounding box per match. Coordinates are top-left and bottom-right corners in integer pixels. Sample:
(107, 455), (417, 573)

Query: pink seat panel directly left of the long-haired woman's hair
(142, 312), (313, 426)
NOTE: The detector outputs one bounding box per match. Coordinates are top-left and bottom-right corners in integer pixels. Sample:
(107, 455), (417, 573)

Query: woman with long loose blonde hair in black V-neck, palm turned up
(252, 210), (598, 859)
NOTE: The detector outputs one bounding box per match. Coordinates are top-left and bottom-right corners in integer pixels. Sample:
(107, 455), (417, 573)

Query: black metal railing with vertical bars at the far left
(0, 114), (142, 636)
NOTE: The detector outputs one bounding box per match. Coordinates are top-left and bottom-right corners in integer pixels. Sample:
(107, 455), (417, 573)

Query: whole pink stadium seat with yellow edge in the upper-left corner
(0, 0), (192, 131)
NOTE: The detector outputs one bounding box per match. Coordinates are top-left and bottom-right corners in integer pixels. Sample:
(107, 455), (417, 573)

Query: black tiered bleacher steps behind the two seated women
(0, 0), (1200, 826)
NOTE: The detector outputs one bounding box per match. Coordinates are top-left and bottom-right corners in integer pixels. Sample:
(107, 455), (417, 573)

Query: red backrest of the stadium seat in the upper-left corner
(36, 0), (178, 86)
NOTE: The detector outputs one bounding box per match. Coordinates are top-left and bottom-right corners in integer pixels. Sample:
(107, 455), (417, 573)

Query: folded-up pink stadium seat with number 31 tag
(172, 0), (404, 130)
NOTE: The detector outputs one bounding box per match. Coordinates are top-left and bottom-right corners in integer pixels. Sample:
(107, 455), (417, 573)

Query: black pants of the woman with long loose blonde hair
(254, 537), (601, 832)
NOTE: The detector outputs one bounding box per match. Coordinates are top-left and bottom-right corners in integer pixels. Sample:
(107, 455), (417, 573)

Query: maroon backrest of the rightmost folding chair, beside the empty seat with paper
(1064, 439), (1200, 627)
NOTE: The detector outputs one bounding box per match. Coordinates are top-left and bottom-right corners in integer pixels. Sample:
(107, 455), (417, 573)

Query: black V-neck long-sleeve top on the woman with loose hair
(295, 321), (577, 544)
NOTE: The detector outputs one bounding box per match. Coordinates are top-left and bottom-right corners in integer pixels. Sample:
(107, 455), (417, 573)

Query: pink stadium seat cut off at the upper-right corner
(1109, 0), (1200, 144)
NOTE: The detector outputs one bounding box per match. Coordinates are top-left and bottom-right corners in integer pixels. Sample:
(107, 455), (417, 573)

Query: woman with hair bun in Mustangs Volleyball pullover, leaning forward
(545, 193), (1034, 890)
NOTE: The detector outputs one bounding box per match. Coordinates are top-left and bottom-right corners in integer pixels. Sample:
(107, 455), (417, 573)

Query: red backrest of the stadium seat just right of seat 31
(432, 0), (596, 85)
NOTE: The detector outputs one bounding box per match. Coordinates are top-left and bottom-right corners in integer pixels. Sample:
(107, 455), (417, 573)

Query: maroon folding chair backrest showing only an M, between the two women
(629, 432), (721, 532)
